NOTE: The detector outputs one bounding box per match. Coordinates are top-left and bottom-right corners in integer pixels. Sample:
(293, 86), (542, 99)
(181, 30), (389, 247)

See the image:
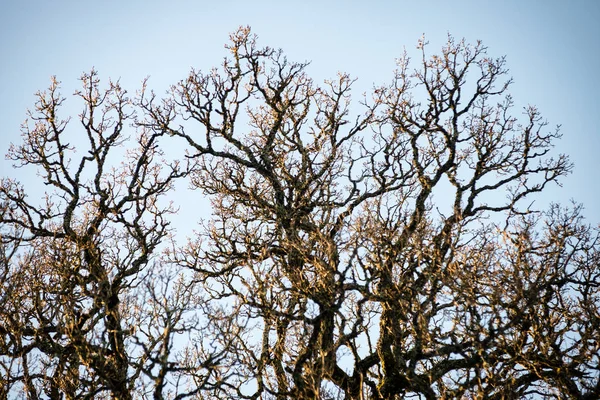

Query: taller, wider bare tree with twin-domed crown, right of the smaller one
(146, 29), (600, 399)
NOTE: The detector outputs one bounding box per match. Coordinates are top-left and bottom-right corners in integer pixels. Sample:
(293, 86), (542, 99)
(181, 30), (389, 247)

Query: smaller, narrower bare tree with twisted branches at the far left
(0, 71), (220, 399)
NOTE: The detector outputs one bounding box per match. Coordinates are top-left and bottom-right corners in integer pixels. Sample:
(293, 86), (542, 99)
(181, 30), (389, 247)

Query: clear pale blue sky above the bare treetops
(0, 0), (600, 224)
